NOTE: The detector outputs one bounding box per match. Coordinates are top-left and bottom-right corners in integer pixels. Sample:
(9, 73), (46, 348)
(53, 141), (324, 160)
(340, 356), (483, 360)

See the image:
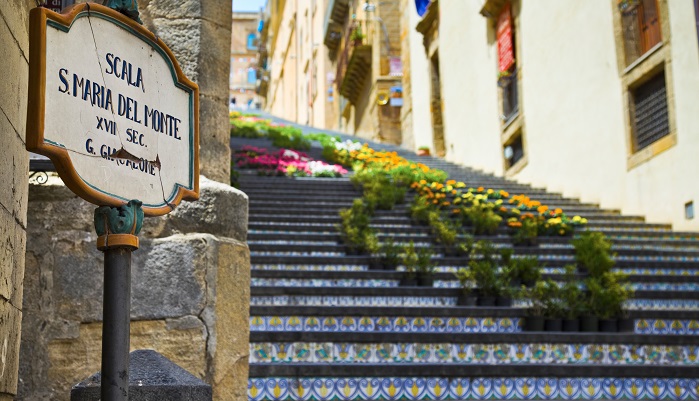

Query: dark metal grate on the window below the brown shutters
(632, 72), (670, 151)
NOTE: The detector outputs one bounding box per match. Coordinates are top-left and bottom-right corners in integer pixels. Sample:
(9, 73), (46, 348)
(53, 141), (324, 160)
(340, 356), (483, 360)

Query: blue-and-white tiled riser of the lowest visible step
(248, 377), (699, 401)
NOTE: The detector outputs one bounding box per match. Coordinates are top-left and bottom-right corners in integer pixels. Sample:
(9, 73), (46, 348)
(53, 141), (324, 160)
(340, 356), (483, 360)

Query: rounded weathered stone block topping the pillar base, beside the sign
(168, 176), (248, 241)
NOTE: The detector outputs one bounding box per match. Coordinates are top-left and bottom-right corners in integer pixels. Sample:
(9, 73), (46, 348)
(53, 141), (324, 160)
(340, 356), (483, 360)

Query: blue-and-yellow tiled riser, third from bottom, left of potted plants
(250, 316), (522, 333)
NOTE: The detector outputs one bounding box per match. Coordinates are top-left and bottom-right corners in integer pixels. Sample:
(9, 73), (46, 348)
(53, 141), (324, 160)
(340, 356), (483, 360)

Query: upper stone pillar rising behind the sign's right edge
(139, 0), (231, 182)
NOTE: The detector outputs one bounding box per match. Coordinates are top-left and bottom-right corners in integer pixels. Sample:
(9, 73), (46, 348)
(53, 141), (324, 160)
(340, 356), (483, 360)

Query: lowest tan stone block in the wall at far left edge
(0, 299), (22, 394)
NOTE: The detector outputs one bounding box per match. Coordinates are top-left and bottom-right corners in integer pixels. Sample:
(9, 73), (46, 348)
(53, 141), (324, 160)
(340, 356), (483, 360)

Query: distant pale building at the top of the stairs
(229, 12), (261, 108)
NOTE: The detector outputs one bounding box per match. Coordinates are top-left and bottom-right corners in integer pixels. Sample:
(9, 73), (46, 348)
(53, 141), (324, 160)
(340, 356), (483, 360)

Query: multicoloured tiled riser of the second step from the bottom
(250, 342), (699, 366)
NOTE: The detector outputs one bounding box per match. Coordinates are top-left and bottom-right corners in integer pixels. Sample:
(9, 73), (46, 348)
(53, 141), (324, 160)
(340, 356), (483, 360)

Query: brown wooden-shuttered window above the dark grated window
(618, 0), (662, 65)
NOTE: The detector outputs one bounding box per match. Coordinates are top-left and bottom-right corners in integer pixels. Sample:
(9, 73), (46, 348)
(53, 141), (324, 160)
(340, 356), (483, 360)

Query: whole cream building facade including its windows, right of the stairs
(411, 0), (699, 230)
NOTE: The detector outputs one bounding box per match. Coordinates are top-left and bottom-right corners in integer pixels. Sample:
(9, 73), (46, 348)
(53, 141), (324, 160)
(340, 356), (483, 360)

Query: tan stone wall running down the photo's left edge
(0, 0), (34, 401)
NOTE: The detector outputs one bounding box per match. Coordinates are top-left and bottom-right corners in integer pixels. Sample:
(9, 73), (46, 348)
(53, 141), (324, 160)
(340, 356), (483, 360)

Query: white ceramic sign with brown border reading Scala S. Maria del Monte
(27, 3), (199, 216)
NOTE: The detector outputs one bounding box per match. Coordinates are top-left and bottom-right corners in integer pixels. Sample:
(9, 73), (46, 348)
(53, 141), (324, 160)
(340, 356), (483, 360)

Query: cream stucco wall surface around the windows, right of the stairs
(430, 0), (699, 230)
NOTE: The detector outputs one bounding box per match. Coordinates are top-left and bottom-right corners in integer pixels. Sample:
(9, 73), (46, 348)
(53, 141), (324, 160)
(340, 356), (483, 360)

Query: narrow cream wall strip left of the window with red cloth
(438, 0), (502, 173)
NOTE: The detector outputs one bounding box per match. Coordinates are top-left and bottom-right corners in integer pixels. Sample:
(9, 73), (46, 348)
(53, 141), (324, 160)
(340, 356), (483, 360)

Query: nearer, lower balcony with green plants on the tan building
(337, 21), (374, 104)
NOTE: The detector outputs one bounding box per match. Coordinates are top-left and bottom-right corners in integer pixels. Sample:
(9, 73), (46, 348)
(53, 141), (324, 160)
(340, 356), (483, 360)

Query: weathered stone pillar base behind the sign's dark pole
(17, 177), (250, 401)
